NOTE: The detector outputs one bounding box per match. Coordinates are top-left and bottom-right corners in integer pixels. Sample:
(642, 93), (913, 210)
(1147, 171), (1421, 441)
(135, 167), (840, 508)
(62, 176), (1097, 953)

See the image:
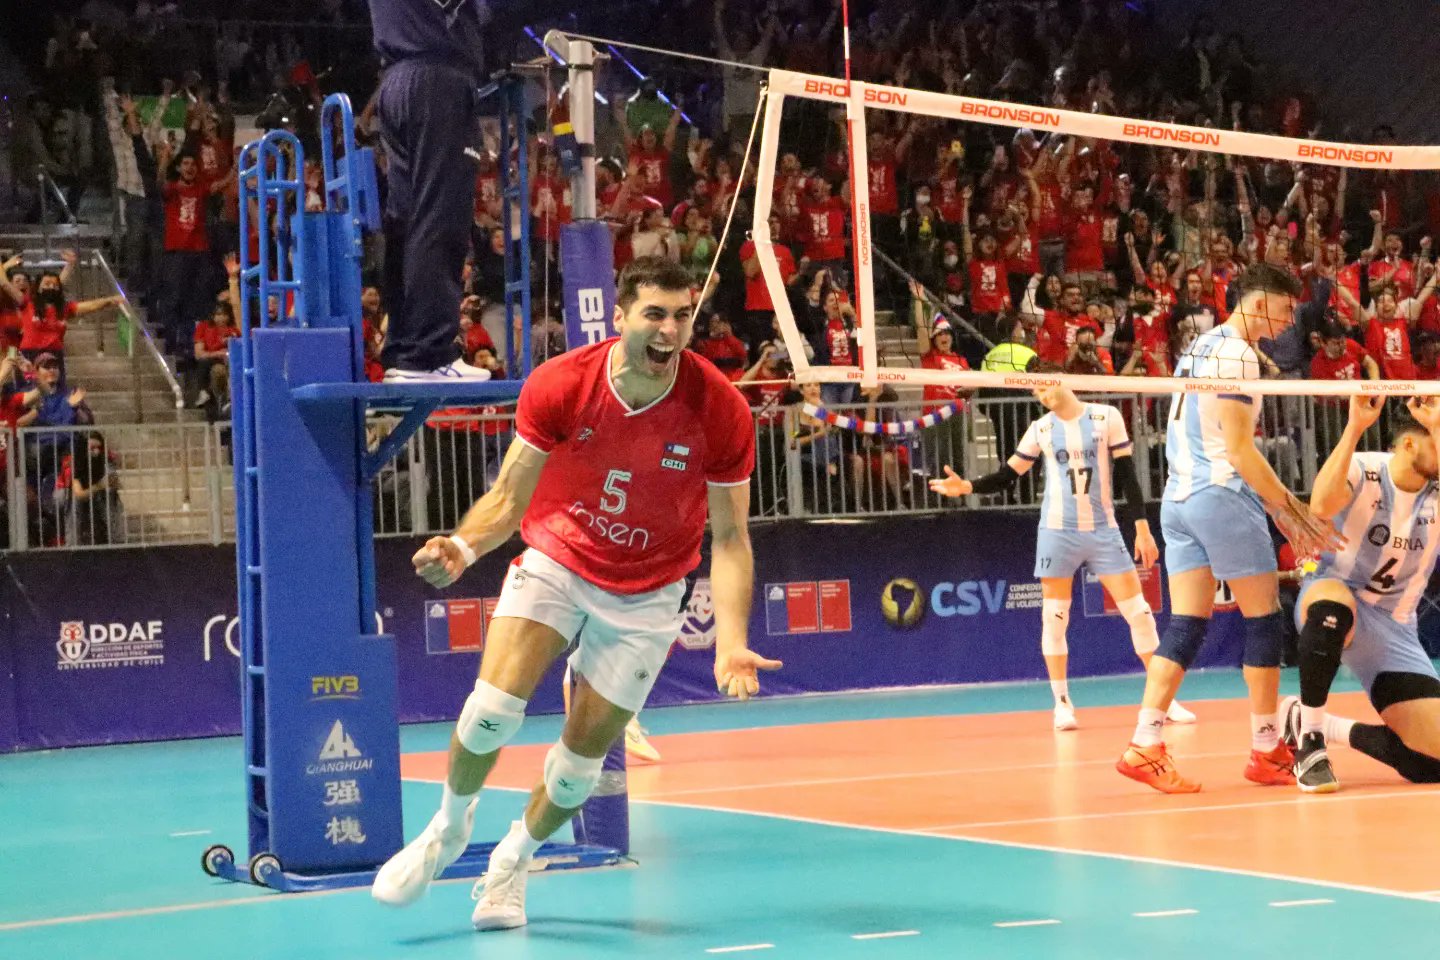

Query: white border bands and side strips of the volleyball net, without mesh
(752, 68), (1440, 396)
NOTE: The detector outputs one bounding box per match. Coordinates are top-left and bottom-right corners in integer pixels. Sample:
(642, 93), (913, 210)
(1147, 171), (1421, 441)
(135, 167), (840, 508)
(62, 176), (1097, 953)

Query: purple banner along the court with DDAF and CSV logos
(0, 514), (1261, 750)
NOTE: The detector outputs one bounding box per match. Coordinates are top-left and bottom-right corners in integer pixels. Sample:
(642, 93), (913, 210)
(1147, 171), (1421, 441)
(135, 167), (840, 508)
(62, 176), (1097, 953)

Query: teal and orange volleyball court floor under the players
(0, 671), (1440, 960)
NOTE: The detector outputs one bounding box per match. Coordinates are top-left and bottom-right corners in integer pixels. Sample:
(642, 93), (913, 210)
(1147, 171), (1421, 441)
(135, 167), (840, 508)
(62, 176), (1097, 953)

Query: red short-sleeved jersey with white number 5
(516, 340), (755, 594)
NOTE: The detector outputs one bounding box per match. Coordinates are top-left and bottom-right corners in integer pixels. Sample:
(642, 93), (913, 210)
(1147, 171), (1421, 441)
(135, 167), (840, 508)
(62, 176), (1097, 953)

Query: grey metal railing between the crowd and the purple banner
(0, 394), (1387, 550)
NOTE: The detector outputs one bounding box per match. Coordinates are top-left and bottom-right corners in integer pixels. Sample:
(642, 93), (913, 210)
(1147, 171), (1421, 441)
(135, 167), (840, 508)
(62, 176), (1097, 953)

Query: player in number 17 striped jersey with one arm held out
(930, 366), (1195, 730)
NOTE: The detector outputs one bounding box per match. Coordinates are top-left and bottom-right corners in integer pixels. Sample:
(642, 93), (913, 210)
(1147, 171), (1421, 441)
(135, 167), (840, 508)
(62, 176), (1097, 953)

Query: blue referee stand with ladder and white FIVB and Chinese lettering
(202, 95), (628, 891)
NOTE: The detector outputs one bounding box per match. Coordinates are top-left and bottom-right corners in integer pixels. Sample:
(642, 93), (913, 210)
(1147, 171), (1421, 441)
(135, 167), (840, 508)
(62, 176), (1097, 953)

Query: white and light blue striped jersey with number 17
(1015, 403), (1130, 530)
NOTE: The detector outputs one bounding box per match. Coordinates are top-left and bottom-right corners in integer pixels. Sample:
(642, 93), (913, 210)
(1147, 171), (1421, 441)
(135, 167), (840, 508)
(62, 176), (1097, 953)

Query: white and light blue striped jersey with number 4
(1315, 453), (1440, 623)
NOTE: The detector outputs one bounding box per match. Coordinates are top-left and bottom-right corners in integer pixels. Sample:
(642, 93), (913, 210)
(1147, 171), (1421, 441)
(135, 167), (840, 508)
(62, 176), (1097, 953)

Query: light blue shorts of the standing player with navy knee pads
(1161, 486), (1276, 580)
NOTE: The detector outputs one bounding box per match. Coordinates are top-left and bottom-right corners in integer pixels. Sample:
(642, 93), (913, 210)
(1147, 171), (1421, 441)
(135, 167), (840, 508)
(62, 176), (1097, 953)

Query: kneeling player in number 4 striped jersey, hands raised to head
(1284, 397), (1440, 793)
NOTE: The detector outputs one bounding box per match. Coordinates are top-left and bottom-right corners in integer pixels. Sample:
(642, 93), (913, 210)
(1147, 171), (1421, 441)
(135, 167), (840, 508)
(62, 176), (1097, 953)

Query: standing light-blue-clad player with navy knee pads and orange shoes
(1116, 263), (1335, 793)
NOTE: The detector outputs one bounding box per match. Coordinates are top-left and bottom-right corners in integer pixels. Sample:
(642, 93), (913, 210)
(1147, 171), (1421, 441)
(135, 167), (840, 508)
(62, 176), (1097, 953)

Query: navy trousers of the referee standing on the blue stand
(377, 60), (480, 370)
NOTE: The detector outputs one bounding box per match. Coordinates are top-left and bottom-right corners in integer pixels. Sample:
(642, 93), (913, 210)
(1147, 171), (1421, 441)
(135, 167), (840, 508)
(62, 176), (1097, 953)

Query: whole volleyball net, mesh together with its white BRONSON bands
(752, 71), (1440, 397)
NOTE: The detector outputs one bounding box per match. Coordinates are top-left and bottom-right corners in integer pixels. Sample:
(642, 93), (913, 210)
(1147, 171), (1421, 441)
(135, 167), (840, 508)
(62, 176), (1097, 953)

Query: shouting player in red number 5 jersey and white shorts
(372, 258), (780, 930)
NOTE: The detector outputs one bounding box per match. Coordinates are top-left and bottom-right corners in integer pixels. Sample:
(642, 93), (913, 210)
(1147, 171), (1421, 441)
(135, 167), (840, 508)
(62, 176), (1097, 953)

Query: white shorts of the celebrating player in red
(495, 547), (685, 712)
